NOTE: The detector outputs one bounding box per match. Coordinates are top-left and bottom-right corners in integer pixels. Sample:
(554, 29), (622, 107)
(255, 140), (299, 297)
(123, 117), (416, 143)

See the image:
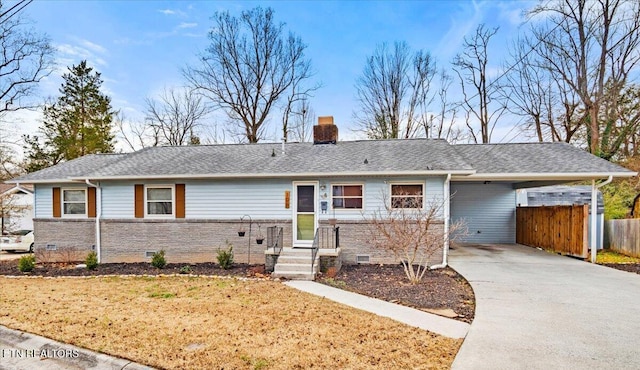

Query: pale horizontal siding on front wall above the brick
(36, 176), (444, 221)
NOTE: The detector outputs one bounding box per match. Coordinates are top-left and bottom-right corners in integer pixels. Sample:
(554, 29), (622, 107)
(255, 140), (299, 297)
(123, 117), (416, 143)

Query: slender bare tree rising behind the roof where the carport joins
(453, 24), (506, 143)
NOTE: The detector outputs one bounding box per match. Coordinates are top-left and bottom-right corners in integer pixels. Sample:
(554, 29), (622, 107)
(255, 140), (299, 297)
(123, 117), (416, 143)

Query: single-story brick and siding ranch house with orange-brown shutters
(6, 117), (635, 276)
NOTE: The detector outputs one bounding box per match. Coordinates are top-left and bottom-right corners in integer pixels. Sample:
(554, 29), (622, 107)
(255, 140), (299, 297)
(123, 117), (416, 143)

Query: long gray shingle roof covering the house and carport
(11, 139), (631, 183)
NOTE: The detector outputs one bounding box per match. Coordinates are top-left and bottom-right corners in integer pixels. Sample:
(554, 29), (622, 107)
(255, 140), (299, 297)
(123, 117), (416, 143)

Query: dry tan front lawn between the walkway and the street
(0, 277), (462, 369)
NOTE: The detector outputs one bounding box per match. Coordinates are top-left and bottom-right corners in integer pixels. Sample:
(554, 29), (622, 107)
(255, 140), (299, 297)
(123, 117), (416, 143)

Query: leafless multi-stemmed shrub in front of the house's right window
(365, 194), (465, 284)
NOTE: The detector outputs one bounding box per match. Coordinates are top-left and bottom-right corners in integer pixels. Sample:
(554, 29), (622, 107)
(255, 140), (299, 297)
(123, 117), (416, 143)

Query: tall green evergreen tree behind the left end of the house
(24, 61), (115, 172)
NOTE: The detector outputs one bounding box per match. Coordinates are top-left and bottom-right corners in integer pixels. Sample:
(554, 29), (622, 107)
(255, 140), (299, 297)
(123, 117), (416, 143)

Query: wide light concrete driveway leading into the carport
(449, 245), (640, 369)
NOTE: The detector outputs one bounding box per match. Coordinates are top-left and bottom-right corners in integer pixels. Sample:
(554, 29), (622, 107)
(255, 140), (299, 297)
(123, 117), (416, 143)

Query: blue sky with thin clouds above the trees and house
(13, 0), (532, 149)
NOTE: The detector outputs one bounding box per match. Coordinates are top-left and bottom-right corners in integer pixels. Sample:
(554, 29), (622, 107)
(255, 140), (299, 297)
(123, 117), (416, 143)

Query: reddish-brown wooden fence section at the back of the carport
(516, 204), (589, 258)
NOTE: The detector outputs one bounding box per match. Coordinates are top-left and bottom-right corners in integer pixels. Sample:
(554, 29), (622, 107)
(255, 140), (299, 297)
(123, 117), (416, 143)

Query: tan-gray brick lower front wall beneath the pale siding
(34, 219), (443, 267)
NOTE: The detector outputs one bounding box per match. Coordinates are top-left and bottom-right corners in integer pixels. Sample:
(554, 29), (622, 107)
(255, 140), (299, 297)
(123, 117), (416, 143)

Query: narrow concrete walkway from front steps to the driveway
(285, 280), (469, 339)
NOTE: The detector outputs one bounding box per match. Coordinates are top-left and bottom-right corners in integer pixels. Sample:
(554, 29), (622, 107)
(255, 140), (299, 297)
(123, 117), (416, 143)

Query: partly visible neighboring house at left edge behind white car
(0, 184), (33, 234)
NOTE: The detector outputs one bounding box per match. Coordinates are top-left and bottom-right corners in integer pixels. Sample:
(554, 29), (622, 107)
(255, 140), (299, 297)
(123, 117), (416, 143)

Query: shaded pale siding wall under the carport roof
(451, 183), (516, 243)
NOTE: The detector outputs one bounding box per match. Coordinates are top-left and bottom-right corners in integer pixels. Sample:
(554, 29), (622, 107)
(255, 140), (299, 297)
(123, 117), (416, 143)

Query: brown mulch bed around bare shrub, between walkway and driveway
(318, 264), (475, 322)
